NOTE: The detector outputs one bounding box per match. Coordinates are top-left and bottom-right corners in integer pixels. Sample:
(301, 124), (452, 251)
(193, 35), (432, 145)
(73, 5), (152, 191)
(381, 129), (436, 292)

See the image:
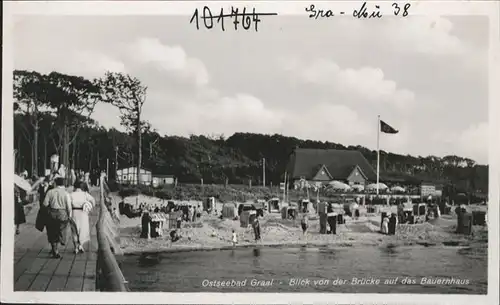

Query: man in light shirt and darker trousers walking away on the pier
(43, 176), (72, 258)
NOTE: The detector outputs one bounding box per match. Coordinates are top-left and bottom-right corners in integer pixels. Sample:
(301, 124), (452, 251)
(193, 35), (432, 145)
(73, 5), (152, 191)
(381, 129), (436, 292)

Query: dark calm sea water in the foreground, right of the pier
(121, 242), (487, 294)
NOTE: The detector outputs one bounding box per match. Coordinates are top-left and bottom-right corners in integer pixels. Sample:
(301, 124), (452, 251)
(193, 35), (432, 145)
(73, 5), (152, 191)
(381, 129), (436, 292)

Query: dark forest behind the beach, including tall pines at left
(14, 71), (488, 193)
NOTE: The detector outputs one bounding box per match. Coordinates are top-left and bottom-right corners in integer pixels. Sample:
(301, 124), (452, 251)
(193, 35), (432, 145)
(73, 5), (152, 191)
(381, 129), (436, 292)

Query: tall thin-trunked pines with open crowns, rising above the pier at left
(13, 70), (147, 185)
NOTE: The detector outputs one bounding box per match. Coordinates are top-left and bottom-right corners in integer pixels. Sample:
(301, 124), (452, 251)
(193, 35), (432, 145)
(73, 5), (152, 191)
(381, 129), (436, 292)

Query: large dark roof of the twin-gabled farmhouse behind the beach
(288, 148), (377, 181)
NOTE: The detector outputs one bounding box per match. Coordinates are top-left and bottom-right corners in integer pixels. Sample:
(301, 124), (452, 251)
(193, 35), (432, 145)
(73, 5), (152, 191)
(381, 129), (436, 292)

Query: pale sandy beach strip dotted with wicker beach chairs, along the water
(115, 192), (488, 254)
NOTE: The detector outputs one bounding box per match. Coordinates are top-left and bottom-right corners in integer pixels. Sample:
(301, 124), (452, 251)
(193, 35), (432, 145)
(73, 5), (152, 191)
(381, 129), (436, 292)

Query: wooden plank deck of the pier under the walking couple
(13, 194), (99, 291)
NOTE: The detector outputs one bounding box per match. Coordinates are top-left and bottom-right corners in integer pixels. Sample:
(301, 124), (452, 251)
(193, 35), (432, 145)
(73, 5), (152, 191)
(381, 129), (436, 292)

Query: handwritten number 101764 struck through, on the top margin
(189, 6), (278, 32)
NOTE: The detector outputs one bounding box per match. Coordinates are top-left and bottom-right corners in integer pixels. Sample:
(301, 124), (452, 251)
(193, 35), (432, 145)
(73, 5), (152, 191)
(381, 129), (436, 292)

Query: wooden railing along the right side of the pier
(96, 173), (128, 292)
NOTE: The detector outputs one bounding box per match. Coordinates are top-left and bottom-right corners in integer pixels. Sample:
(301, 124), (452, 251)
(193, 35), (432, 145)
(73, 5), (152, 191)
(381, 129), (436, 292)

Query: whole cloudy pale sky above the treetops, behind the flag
(14, 16), (488, 163)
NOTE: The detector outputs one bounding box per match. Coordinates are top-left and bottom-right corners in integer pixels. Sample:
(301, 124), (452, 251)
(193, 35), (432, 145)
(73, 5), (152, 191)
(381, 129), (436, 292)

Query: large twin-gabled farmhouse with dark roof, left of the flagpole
(287, 148), (377, 185)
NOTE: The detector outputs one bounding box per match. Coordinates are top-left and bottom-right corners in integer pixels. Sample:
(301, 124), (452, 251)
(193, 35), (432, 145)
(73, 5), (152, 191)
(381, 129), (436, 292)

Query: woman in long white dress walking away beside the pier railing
(71, 181), (95, 253)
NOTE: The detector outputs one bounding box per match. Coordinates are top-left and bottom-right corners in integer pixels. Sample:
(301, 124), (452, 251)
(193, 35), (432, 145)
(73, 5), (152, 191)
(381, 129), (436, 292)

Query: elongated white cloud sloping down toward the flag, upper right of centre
(290, 59), (415, 108)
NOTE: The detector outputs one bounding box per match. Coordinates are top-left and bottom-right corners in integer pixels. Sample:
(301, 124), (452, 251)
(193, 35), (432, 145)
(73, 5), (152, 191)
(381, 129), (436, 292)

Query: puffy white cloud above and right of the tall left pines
(129, 38), (209, 85)
